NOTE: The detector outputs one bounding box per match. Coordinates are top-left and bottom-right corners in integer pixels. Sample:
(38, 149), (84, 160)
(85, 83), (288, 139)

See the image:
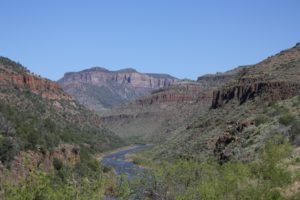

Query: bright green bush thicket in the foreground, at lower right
(134, 135), (291, 200)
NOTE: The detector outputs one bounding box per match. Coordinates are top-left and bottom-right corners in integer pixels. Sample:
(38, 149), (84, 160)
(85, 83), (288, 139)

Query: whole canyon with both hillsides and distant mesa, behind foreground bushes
(0, 44), (300, 197)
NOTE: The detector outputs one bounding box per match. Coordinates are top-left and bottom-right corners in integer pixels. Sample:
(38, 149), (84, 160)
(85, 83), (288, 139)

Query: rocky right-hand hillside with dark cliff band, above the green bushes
(157, 44), (300, 162)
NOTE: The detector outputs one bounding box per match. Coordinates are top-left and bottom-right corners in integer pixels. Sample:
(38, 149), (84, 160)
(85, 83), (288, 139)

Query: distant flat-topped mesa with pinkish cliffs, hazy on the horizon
(58, 67), (177, 112)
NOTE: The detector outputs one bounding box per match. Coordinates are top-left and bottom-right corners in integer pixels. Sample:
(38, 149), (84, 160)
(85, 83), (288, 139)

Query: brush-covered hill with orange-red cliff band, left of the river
(0, 57), (123, 170)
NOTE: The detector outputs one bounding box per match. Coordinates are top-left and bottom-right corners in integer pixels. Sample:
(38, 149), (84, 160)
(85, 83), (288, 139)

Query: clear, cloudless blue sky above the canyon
(0, 0), (300, 80)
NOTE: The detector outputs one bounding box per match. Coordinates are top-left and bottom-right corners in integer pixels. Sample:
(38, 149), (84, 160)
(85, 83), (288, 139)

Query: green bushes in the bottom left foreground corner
(0, 165), (105, 200)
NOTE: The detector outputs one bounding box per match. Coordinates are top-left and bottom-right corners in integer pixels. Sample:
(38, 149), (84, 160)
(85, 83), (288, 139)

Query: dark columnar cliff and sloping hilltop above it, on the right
(212, 44), (300, 108)
